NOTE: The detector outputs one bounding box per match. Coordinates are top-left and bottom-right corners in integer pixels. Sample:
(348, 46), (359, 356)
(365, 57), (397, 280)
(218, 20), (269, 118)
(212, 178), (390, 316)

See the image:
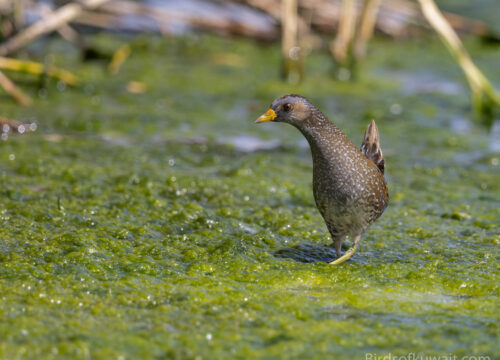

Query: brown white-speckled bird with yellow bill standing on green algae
(255, 94), (389, 265)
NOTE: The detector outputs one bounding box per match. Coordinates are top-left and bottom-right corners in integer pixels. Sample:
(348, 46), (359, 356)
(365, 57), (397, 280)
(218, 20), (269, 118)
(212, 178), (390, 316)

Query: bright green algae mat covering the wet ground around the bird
(0, 36), (500, 360)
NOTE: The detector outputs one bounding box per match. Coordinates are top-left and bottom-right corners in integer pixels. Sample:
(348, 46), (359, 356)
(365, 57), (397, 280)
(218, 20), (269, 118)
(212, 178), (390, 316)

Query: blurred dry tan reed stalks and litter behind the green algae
(0, 0), (500, 125)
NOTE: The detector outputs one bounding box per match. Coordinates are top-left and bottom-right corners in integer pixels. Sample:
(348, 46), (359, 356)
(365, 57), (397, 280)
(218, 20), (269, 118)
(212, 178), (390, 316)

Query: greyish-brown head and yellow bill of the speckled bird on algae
(255, 94), (314, 128)
